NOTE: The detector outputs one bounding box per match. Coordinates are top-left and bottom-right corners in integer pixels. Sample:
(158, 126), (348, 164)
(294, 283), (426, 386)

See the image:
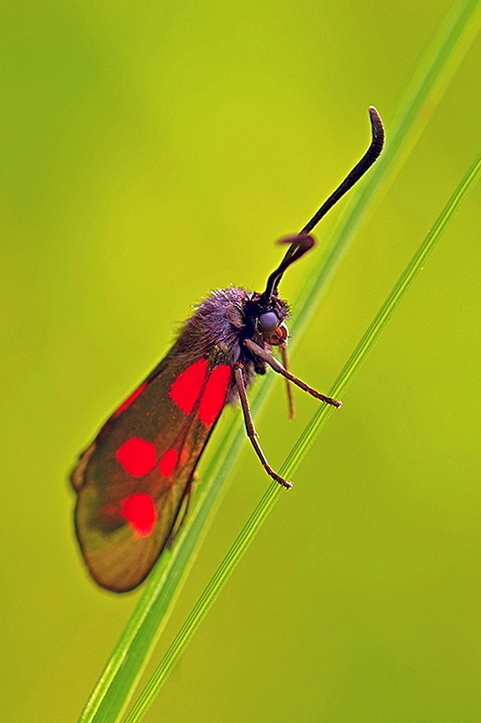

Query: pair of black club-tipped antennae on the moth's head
(263, 106), (385, 298)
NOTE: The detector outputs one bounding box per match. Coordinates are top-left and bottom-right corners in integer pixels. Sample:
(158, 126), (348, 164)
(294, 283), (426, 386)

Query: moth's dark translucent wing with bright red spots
(71, 356), (232, 592)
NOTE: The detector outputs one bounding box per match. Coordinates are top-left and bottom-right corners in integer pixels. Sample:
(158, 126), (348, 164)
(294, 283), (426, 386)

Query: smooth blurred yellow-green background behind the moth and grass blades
(0, 0), (481, 723)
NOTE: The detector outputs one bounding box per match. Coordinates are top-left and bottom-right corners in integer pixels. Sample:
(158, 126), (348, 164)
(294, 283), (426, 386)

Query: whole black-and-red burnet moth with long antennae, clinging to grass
(71, 108), (384, 592)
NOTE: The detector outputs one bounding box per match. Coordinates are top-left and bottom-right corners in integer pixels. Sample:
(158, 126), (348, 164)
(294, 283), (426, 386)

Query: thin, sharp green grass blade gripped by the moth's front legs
(126, 148), (481, 723)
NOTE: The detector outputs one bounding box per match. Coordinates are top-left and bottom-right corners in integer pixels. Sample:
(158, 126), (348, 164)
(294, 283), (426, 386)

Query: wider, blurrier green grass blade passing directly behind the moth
(75, 0), (481, 723)
